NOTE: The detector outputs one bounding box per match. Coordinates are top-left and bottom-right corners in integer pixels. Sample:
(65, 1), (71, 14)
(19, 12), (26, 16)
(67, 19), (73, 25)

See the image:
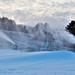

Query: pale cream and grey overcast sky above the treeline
(0, 0), (75, 25)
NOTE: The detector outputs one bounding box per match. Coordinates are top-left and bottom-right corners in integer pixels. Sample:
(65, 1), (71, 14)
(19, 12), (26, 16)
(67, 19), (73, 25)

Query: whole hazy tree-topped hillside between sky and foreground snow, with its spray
(0, 17), (75, 51)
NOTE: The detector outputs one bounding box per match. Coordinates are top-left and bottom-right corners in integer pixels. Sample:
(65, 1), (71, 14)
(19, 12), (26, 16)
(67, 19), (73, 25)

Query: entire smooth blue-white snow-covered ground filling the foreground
(0, 50), (75, 75)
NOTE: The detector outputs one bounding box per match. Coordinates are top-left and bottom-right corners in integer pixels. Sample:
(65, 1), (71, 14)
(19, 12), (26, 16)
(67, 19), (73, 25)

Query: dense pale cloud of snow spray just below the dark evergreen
(53, 29), (75, 47)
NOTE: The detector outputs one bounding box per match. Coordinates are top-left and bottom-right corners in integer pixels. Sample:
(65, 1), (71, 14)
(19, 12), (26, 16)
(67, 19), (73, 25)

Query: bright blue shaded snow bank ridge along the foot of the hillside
(0, 50), (75, 63)
